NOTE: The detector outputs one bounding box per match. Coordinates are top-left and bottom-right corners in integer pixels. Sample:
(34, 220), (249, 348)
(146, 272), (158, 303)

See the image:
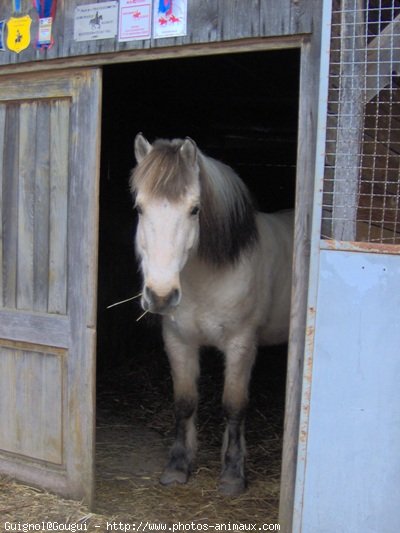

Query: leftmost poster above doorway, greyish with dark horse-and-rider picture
(74, 1), (118, 41)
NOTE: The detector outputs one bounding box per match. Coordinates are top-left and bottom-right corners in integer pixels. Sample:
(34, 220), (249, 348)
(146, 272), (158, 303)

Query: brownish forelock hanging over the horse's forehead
(131, 139), (196, 201)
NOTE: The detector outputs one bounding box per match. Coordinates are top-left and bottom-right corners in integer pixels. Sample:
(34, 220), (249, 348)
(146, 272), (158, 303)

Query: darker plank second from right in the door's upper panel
(33, 100), (50, 312)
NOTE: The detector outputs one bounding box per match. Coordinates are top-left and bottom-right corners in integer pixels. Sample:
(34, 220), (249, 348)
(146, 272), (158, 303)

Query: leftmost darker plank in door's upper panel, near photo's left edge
(3, 104), (19, 308)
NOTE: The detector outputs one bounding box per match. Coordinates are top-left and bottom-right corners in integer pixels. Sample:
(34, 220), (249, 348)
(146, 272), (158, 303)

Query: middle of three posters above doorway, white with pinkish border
(118, 0), (153, 41)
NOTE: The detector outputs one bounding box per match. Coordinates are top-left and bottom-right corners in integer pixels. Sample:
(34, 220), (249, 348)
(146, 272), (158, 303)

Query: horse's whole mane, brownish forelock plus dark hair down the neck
(131, 139), (258, 266)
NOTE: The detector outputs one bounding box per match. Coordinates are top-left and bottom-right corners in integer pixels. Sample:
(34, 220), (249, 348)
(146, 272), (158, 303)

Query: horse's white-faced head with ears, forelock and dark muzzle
(131, 134), (200, 314)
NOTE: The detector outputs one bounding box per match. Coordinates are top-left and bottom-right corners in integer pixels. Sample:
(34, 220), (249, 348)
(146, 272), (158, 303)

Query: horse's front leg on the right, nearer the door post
(219, 336), (257, 496)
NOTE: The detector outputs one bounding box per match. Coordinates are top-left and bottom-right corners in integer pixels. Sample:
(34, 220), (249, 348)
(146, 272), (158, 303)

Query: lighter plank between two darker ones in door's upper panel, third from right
(17, 102), (37, 310)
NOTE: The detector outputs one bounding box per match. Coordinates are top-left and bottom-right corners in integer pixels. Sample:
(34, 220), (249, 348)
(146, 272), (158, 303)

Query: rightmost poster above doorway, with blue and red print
(153, 0), (187, 39)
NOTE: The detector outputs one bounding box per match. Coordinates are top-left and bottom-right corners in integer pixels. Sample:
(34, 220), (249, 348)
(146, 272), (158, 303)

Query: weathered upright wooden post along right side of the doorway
(279, 0), (323, 532)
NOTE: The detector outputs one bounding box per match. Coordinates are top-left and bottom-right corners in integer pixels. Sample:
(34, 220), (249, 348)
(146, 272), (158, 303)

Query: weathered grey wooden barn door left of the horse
(0, 69), (101, 504)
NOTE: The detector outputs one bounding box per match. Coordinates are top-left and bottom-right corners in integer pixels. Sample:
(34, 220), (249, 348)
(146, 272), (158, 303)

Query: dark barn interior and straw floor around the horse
(96, 49), (300, 521)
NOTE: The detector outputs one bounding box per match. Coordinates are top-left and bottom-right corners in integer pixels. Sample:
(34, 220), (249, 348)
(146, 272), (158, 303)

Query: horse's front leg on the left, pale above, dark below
(160, 328), (199, 485)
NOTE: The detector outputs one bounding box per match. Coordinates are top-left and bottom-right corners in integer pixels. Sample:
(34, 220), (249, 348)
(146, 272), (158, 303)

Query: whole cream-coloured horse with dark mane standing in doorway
(130, 133), (293, 496)
